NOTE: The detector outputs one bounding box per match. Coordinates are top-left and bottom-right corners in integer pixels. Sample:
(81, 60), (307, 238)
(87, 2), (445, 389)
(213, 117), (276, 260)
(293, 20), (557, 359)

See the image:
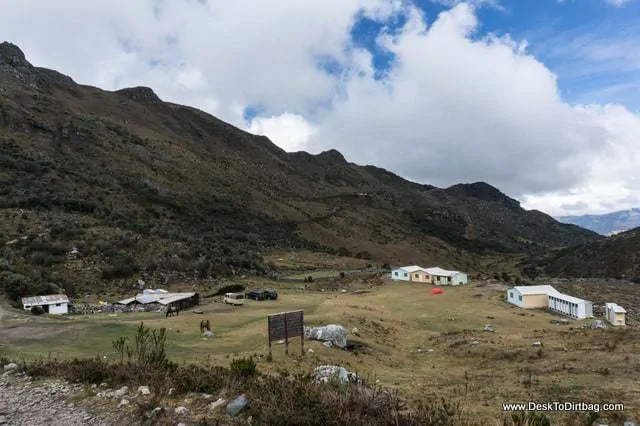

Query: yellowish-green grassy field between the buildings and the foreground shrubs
(0, 283), (640, 424)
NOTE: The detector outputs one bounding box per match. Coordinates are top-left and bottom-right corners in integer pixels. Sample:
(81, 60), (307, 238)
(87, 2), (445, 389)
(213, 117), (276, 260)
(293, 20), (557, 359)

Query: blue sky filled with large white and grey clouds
(0, 0), (640, 216)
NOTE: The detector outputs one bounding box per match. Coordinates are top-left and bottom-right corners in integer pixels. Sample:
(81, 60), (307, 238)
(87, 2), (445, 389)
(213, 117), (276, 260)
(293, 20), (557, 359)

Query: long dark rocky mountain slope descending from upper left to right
(0, 43), (599, 298)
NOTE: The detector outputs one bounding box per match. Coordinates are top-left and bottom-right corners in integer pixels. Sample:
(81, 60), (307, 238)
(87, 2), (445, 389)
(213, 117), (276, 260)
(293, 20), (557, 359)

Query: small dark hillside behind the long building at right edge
(521, 228), (640, 281)
